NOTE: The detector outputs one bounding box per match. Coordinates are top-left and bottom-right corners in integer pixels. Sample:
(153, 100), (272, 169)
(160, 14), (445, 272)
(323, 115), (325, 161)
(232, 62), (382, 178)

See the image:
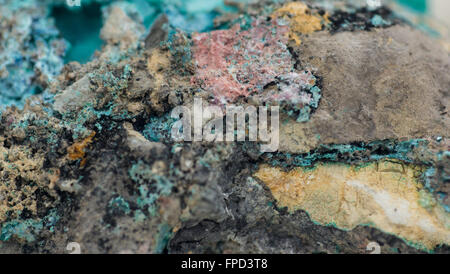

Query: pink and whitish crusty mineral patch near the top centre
(192, 17), (311, 104)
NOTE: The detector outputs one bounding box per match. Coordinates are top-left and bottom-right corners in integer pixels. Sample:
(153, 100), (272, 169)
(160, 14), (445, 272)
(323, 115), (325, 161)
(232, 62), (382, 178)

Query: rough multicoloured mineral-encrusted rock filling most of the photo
(0, 1), (450, 253)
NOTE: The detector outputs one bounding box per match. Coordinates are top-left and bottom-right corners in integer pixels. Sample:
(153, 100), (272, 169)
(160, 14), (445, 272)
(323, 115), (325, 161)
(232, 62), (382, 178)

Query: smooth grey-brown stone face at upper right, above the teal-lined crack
(280, 25), (450, 153)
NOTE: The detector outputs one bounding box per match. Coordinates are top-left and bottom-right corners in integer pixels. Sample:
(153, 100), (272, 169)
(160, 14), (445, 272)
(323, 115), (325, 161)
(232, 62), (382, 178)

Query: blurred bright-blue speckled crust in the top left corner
(0, 0), (67, 111)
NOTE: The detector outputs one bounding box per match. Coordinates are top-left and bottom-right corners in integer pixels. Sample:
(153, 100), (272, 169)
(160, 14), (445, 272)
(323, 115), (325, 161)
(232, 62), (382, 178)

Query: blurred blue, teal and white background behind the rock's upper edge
(0, 0), (450, 109)
